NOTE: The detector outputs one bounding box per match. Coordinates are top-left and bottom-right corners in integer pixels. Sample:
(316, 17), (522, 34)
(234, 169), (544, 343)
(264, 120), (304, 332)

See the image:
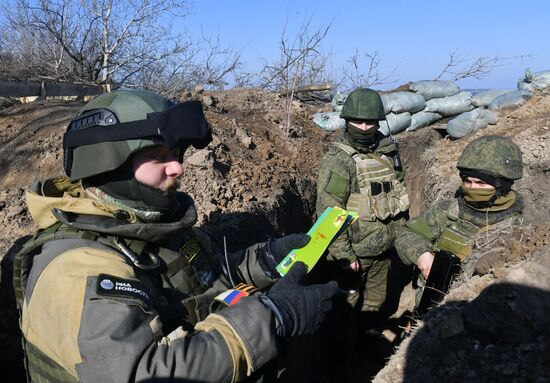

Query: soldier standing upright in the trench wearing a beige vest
(317, 88), (424, 336)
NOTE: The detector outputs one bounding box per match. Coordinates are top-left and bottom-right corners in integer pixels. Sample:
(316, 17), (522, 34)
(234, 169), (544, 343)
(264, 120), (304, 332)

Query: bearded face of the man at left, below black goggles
(132, 145), (183, 191)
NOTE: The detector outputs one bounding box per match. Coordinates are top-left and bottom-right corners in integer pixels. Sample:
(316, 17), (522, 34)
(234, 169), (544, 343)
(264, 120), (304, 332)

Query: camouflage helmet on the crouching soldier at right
(456, 136), (523, 181)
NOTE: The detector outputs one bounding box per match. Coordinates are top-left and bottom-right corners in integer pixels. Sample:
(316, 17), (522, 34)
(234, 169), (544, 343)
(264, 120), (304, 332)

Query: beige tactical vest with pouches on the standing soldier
(334, 142), (409, 221)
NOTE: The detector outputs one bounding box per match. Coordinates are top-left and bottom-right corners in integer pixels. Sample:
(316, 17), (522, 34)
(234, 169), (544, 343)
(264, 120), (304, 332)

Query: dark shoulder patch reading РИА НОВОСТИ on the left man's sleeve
(96, 274), (151, 307)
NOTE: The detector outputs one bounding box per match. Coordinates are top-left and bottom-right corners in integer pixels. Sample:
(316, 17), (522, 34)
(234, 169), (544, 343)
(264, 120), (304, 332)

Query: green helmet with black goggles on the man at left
(63, 89), (211, 180)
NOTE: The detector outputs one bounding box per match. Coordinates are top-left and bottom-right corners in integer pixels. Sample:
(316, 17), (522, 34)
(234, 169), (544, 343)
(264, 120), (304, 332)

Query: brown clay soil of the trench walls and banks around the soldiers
(0, 89), (550, 382)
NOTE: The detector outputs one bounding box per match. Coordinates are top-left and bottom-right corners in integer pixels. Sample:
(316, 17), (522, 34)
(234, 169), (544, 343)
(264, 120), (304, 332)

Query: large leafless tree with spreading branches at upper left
(0, 0), (240, 96)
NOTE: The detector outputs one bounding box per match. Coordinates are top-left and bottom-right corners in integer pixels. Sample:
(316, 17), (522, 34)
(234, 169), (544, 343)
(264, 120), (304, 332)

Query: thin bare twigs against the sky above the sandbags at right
(434, 49), (531, 81)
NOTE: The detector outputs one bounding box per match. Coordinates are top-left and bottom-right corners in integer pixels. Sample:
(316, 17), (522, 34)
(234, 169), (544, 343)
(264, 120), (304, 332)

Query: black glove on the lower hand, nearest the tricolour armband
(260, 262), (338, 337)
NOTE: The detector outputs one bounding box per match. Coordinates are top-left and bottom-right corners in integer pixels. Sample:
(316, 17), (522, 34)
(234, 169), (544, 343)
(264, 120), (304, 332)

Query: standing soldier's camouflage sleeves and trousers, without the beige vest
(316, 135), (414, 311)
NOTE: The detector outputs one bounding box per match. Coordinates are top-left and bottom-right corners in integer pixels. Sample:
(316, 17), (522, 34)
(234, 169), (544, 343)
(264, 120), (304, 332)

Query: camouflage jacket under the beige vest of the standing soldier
(316, 136), (418, 265)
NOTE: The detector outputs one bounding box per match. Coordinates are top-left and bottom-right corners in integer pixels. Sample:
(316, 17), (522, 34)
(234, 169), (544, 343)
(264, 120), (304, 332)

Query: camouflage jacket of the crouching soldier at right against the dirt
(395, 193), (523, 264)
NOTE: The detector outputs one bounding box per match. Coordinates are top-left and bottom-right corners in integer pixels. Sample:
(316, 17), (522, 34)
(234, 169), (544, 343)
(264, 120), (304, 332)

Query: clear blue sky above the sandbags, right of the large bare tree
(185, 0), (550, 88)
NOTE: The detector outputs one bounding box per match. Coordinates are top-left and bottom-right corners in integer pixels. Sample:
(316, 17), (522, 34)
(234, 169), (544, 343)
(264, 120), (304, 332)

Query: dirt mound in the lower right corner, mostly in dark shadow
(374, 225), (550, 383)
